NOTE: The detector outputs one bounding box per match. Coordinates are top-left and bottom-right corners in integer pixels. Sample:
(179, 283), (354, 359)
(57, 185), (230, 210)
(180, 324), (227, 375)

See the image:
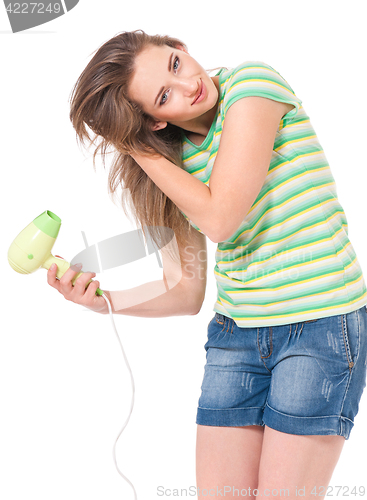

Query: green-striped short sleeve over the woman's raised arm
(223, 61), (302, 119)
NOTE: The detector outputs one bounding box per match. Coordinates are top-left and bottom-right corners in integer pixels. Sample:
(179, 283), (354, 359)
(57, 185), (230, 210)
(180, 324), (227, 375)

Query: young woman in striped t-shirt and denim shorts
(48, 31), (367, 498)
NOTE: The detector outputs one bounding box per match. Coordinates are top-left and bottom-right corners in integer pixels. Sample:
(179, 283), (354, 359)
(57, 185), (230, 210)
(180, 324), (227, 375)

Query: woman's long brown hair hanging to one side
(70, 30), (196, 260)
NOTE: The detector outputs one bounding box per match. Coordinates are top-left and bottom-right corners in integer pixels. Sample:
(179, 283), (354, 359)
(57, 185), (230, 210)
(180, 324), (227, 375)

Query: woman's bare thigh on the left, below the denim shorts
(196, 425), (264, 499)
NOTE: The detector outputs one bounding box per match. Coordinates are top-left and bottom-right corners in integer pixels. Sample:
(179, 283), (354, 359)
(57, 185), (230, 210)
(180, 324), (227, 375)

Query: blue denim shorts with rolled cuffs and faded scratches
(196, 306), (367, 439)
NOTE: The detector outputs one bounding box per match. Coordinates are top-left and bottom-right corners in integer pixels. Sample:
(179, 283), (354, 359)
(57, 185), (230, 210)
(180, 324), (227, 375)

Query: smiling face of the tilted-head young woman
(129, 45), (219, 130)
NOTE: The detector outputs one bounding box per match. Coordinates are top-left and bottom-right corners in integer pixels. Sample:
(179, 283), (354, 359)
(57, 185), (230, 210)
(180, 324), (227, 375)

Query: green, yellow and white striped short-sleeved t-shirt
(183, 61), (367, 327)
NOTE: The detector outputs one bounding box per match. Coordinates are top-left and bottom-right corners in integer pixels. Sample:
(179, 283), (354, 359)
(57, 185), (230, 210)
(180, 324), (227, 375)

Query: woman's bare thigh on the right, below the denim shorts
(258, 426), (345, 500)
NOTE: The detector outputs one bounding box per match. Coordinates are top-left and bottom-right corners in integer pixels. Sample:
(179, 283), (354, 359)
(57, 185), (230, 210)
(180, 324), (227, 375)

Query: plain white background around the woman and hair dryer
(0, 0), (367, 500)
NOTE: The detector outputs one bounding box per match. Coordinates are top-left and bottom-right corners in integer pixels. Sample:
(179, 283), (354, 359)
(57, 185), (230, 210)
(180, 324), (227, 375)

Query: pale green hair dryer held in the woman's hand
(8, 210), (103, 295)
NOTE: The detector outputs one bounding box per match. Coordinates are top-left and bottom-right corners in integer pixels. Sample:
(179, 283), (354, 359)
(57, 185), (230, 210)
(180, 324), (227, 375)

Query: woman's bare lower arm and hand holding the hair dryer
(47, 229), (207, 318)
